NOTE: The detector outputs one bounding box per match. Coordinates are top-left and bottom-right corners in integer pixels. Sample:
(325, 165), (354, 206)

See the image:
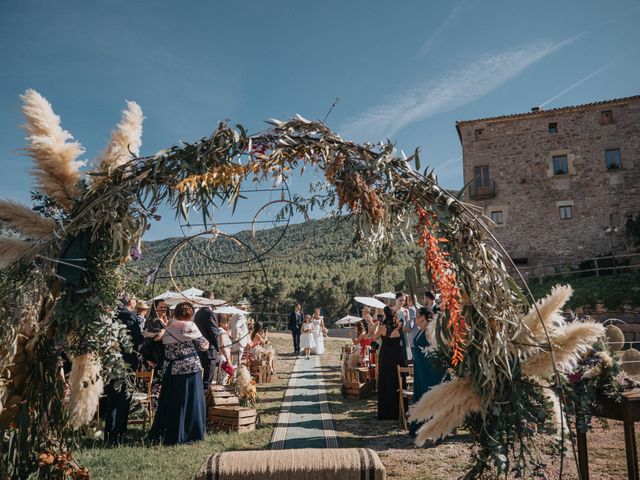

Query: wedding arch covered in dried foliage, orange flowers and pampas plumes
(0, 91), (602, 478)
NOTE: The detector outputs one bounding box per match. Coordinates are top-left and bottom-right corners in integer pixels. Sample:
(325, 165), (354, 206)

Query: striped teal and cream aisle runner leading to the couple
(271, 356), (338, 450)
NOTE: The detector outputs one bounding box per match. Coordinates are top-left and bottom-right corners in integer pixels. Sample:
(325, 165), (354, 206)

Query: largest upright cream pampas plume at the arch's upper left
(21, 89), (84, 210)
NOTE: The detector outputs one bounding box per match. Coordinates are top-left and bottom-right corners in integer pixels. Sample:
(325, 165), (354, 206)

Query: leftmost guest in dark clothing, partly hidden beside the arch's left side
(104, 296), (144, 444)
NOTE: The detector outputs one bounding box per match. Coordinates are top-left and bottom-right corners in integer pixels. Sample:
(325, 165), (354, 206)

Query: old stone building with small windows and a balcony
(456, 95), (640, 267)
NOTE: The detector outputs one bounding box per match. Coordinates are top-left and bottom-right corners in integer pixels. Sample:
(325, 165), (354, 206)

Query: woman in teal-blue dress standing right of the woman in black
(409, 307), (443, 435)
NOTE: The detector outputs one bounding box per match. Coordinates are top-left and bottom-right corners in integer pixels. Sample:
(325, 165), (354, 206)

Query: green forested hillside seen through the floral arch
(129, 219), (418, 317)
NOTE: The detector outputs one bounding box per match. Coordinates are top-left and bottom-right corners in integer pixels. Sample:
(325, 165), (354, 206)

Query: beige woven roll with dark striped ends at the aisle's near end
(195, 448), (386, 480)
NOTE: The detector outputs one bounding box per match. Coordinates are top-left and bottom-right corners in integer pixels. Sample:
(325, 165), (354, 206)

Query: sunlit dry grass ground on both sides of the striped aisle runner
(78, 334), (640, 480)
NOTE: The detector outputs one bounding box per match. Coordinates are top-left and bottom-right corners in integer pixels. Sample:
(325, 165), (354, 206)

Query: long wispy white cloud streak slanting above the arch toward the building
(339, 34), (583, 141)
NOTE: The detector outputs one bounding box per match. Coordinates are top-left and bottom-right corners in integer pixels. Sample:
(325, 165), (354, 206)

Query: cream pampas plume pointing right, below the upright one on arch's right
(522, 321), (604, 377)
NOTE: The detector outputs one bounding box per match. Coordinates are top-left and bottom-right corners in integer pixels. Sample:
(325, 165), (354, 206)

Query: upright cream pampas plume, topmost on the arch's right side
(516, 285), (573, 343)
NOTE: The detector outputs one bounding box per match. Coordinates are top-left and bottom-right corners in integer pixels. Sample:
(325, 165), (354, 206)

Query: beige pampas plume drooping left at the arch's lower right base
(409, 377), (481, 447)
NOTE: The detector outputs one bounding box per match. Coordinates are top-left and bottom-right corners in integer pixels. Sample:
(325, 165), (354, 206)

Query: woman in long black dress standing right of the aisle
(373, 306), (406, 420)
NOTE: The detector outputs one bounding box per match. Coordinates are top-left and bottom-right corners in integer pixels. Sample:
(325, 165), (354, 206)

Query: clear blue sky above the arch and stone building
(0, 0), (640, 239)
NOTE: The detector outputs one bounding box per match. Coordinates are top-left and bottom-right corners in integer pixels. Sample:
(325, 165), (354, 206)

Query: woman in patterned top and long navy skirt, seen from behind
(149, 302), (209, 445)
